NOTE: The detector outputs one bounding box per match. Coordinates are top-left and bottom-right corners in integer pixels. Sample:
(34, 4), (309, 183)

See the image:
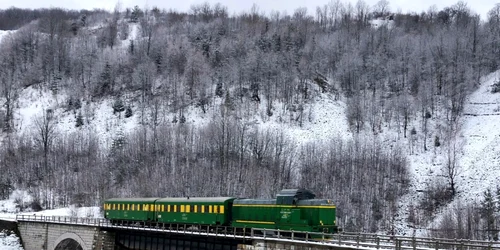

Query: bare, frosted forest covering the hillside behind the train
(0, 0), (500, 239)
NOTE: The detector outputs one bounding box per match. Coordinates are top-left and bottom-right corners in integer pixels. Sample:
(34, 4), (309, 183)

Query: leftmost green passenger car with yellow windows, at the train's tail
(104, 198), (158, 221)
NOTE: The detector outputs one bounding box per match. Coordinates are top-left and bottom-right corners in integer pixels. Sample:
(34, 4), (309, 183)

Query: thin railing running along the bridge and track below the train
(16, 215), (500, 250)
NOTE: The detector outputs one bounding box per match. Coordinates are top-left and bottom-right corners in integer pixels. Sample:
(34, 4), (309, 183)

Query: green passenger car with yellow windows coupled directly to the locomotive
(155, 197), (235, 225)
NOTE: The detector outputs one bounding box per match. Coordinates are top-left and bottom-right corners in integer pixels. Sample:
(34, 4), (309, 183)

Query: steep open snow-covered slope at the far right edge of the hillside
(458, 72), (500, 199)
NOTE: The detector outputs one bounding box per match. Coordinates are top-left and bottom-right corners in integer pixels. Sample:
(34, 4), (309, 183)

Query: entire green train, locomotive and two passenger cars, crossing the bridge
(104, 189), (337, 233)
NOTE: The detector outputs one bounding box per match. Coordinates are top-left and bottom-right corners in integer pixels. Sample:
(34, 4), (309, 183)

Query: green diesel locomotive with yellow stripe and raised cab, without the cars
(233, 189), (337, 233)
